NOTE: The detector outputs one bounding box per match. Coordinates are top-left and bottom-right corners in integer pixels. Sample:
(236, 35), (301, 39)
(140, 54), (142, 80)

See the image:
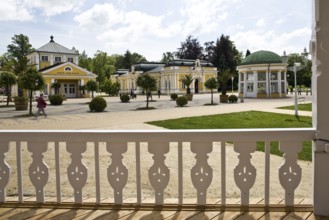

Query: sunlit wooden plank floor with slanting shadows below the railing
(0, 198), (329, 220)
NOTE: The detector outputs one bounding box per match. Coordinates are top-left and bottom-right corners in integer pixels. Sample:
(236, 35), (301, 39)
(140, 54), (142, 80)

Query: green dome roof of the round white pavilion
(240, 50), (282, 65)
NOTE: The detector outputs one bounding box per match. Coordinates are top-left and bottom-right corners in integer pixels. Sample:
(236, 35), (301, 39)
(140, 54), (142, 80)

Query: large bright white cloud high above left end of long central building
(74, 3), (181, 48)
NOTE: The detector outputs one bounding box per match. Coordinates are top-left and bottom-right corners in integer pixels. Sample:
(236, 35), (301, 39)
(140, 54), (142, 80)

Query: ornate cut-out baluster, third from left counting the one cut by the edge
(66, 142), (88, 203)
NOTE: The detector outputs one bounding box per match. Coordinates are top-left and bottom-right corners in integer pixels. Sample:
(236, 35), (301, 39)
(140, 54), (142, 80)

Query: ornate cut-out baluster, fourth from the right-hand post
(148, 142), (170, 205)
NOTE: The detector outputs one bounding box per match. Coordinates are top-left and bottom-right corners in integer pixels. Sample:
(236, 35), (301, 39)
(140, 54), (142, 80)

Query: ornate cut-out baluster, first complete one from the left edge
(27, 142), (49, 203)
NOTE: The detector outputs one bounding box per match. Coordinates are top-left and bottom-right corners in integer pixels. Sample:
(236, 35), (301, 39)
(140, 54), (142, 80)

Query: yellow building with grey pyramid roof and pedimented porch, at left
(27, 36), (97, 98)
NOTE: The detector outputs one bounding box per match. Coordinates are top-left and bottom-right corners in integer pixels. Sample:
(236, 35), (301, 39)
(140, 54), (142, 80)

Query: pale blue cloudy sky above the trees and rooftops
(0, 0), (312, 61)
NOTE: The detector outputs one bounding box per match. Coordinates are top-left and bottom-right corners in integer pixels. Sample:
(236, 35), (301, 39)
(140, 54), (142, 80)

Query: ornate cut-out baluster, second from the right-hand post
(234, 142), (257, 206)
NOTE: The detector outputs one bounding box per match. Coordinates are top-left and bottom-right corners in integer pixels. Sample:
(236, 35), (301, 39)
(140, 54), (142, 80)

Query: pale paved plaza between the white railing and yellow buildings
(0, 94), (312, 130)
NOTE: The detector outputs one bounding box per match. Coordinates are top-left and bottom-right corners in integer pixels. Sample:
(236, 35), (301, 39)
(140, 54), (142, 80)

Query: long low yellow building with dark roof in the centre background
(115, 59), (217, 95)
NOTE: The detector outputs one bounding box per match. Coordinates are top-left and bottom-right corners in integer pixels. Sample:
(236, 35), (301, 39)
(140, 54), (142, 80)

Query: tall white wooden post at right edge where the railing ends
(310, 0), (329, 216)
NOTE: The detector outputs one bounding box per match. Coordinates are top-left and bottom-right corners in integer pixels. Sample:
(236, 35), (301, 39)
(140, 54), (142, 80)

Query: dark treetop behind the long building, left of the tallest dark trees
(176, 35), (203, 60)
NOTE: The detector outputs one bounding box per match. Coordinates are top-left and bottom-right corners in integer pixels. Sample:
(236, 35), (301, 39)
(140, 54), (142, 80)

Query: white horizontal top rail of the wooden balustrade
(0, 128), (316, 142)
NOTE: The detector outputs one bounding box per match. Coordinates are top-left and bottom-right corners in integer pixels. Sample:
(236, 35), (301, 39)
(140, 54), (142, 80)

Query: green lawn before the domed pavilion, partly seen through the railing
(147, 111), (312, 161)
